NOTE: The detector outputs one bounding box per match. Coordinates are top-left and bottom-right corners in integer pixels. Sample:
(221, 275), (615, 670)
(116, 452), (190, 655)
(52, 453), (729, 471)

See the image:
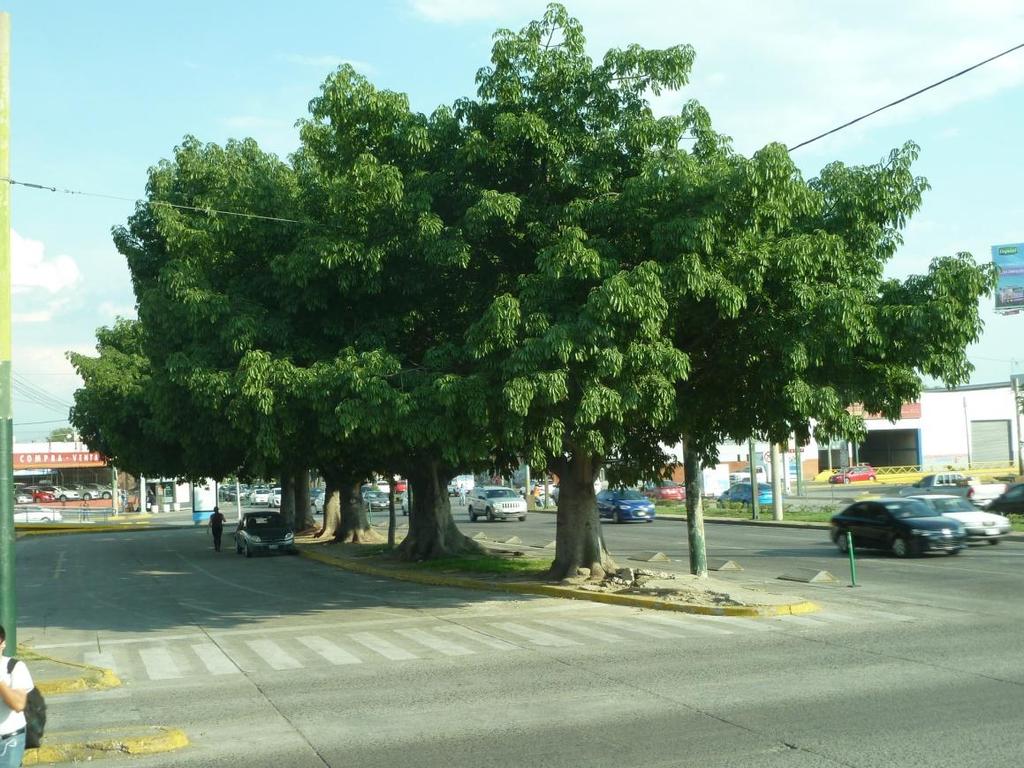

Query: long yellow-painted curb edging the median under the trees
(297, 545), (820, 617)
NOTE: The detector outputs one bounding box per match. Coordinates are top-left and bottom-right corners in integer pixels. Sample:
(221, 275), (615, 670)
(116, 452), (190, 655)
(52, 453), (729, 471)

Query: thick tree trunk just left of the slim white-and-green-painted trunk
(548, 456), (617, 581)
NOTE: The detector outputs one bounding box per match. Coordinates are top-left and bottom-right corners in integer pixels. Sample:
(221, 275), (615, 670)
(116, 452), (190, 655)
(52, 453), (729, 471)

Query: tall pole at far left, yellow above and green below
(0, 13), (17, 654)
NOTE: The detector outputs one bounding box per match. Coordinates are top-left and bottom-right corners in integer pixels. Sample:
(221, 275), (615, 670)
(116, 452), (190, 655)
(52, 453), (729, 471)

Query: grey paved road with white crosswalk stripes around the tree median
(17, 528), (1024, 768)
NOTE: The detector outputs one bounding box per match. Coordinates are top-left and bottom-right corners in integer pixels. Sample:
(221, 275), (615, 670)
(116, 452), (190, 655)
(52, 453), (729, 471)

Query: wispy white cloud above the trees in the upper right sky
(410, 0), (1024, 157)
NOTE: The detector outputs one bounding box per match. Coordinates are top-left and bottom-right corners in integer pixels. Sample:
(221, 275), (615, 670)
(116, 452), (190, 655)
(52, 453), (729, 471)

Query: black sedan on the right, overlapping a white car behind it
(831, 499), (967, 557)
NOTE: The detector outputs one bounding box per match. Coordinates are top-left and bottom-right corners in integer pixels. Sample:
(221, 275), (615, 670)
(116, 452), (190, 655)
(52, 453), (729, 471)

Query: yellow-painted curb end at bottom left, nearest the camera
(23, 726), (189, 765)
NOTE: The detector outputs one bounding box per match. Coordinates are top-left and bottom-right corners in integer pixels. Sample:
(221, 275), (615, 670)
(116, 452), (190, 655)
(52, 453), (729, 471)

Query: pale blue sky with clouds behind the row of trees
(6, 0), (1024, 440)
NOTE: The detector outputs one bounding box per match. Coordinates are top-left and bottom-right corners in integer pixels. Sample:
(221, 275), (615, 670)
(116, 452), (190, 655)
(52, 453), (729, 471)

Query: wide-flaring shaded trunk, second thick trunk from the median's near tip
(397, 461), (483, 560)
